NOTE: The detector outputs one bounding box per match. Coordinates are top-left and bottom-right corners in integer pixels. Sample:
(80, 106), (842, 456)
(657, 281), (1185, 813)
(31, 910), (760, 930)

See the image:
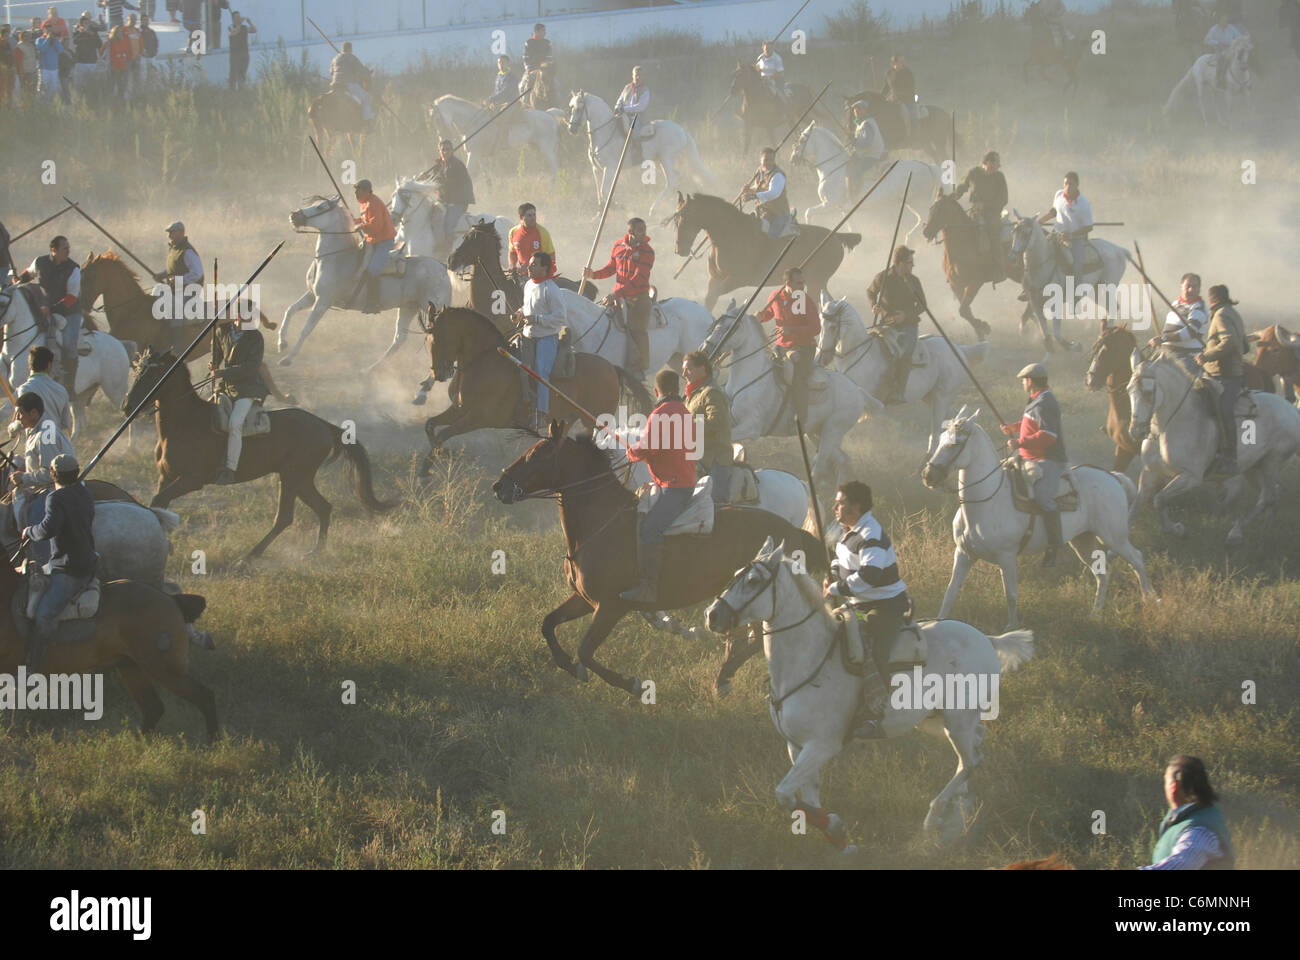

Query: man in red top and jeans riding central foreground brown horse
(619, 369), (696, 604)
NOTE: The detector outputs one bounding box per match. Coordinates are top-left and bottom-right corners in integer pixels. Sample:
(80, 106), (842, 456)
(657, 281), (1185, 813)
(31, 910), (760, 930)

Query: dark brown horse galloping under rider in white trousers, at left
(122, 350), (397, 562)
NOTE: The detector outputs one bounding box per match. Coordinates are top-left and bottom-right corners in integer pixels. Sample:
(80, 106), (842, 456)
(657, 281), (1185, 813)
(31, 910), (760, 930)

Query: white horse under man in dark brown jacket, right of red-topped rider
(818, 290), (988, 454)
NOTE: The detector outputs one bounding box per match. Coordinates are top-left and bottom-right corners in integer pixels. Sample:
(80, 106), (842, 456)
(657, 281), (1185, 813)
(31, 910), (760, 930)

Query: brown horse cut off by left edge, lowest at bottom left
(0, 561), (218, 740)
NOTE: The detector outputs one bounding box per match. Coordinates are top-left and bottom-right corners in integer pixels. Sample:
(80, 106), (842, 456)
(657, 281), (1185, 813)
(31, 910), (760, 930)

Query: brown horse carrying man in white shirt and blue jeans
(424, 307), (654, 454)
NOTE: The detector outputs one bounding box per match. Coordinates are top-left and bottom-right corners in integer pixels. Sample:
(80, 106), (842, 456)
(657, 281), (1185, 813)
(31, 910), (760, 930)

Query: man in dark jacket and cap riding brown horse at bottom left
(22, 453), (99, 673)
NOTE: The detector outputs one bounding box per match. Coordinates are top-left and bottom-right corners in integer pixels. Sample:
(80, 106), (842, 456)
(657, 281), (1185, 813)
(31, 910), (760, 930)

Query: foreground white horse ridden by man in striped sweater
(706, 537), (1034, 855)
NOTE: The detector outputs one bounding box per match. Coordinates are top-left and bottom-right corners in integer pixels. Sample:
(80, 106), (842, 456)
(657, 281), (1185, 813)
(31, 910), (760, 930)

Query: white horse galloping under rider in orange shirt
(277, 196), (451, 371)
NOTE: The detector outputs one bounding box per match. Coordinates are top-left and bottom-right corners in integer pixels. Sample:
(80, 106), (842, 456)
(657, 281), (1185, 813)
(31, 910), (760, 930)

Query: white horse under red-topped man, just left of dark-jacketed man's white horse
(703, 302), (884, 498)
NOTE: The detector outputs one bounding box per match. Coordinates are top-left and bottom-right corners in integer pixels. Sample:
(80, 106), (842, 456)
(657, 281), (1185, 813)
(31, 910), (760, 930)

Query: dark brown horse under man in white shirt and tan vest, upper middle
(670, 194), (862, 312)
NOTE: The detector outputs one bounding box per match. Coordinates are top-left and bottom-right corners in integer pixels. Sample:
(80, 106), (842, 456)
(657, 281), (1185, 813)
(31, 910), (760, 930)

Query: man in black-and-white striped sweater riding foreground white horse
(823, 480), (911, 740)
